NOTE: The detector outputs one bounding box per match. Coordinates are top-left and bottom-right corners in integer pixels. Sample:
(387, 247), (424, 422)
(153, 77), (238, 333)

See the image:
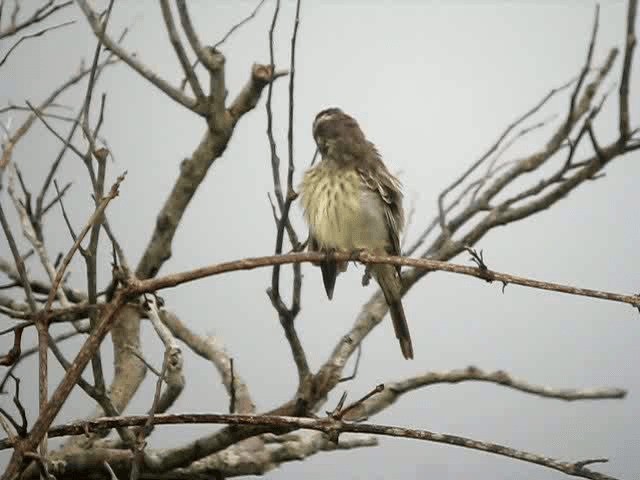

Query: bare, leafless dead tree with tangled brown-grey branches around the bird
(0, 0), (640, 479)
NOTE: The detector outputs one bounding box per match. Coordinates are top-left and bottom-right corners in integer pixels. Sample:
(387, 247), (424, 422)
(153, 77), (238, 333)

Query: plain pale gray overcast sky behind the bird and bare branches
(0, 0), (640, 479)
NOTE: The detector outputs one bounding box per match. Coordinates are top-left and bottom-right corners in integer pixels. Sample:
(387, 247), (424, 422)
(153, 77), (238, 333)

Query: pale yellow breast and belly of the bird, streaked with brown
(301, 165), (388, 251)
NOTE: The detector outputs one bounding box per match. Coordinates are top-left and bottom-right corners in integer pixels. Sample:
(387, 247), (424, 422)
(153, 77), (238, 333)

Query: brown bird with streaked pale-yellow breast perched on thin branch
(300, 108), (413, 358)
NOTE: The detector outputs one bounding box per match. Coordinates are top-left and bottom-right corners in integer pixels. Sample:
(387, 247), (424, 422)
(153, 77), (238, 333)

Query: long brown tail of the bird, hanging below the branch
(372, 265), (413, 359)
